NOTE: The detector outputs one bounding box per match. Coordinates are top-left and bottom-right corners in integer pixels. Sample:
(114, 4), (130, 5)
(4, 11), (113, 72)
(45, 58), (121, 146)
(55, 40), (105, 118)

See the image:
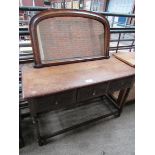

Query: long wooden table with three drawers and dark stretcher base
(22, 58), (135, 145)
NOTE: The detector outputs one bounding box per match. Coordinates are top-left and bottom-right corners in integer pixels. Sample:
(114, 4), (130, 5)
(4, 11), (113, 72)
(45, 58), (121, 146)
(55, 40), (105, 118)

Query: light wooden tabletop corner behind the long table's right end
(113, 52), (135, 67)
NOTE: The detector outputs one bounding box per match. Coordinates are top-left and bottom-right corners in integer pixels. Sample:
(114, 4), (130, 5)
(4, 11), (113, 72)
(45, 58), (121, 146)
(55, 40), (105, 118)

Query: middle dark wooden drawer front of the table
(77, 82), (108, 101)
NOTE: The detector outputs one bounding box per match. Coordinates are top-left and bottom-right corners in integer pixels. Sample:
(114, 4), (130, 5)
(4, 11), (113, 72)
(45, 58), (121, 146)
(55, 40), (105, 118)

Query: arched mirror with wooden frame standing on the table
(30, 9), (110, 67)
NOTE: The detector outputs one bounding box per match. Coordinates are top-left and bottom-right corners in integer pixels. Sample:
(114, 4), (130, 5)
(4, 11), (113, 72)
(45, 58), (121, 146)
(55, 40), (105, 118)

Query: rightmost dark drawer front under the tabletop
(108, 76), (133, 92)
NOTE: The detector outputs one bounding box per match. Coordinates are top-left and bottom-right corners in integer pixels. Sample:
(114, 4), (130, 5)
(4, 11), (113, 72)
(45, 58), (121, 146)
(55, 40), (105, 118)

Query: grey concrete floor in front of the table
(19, 103), (135, 155)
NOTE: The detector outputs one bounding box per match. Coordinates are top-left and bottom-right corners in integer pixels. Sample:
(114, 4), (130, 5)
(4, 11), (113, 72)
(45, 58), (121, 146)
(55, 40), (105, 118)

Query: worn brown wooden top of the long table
(22, 57), (135, 99)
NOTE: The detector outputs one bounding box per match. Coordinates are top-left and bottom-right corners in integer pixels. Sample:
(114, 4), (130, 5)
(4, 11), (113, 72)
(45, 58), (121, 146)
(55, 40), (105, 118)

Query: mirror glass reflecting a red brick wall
(37, 17), (104, 63)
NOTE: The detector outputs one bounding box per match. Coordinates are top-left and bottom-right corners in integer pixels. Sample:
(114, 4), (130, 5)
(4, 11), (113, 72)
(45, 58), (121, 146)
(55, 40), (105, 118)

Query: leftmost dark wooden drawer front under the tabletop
(30, 90), (76, 114)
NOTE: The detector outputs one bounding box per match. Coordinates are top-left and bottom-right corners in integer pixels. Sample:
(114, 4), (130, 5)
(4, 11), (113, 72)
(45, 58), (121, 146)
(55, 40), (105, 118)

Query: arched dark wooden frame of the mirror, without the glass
(29, 9), (110, 68)
